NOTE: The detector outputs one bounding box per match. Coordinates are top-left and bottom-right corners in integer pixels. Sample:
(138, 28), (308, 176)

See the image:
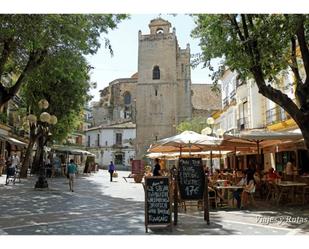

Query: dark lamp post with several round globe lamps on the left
(27, 99), (58, 188)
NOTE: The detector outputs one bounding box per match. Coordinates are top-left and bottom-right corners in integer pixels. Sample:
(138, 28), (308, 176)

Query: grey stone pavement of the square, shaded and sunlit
(0, 170), (309, 235)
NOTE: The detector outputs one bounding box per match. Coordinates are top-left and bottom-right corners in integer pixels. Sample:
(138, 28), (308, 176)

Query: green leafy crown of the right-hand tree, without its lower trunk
(192, 14), (309, 83)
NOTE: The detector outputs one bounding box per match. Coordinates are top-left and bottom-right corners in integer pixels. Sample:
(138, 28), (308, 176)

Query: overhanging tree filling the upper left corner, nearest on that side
(0, 14), (127, 108)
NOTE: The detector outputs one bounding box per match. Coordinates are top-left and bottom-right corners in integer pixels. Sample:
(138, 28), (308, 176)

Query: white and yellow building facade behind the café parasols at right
(215, 70), (308, 172)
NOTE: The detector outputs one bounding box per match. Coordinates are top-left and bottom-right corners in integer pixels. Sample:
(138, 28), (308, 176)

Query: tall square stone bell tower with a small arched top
(136, 18), (192, 158)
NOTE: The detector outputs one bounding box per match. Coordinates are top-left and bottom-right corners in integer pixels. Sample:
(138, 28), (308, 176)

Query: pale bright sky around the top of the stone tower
(87, 14), (211, 101)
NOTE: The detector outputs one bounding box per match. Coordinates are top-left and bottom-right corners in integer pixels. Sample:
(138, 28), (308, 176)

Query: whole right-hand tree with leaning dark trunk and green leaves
(192, 14), (309, 150)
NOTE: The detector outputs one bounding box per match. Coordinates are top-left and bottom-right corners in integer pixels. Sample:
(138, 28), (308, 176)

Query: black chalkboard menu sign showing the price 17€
(178, 158), (205, 200)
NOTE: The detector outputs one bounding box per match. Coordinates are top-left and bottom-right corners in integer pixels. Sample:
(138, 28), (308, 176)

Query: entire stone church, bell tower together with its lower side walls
(93, 18), (221, 159)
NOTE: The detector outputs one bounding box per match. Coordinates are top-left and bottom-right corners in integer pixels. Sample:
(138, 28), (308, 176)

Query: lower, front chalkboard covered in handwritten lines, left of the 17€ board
(145, 176), (172, 232)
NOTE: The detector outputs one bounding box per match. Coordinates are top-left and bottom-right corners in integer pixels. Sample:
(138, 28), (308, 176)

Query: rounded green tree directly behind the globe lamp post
(21, 49), (91, 177)
